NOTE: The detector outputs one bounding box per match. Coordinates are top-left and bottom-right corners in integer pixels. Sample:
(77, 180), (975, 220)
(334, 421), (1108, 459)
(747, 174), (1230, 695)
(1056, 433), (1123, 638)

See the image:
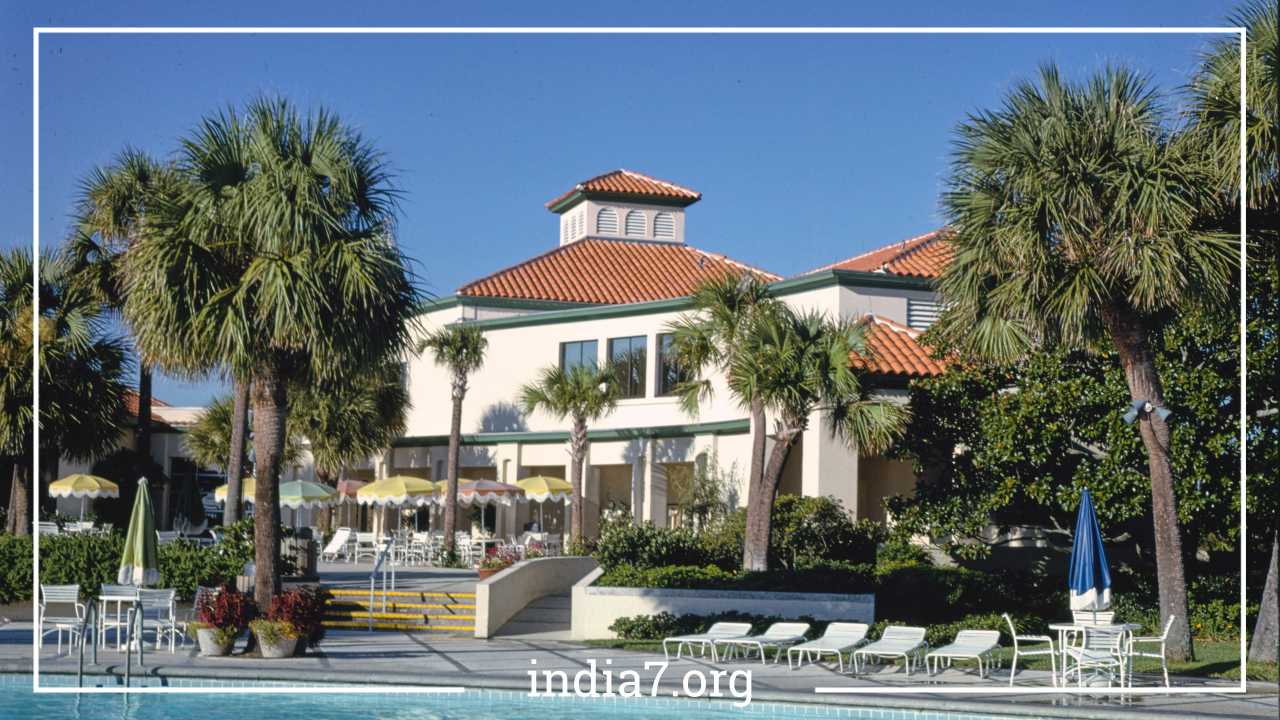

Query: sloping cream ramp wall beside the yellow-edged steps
(476, 557), (599, 638)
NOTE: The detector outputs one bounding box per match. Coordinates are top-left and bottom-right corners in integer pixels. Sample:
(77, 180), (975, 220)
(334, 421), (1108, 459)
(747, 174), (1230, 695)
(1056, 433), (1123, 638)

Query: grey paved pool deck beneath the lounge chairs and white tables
(0, 621), (1277, 719)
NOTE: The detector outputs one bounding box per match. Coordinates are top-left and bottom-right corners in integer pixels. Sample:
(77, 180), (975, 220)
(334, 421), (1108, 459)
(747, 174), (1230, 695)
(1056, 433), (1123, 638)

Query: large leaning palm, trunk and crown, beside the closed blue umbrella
(938, 67), (1238, 659)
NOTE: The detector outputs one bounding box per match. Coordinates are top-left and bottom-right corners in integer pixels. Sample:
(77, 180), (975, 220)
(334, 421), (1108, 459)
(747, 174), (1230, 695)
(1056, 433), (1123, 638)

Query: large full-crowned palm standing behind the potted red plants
(124, 99), (419, 607)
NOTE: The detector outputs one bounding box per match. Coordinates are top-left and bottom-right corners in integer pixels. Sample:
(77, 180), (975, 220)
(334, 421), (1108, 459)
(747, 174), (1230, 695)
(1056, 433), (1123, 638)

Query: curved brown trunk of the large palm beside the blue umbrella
(1102, 299), (1194, 661)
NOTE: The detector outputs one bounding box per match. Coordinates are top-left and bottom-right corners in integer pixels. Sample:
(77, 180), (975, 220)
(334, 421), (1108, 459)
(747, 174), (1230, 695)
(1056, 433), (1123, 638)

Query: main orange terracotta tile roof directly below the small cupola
(458, 237), (781, 305)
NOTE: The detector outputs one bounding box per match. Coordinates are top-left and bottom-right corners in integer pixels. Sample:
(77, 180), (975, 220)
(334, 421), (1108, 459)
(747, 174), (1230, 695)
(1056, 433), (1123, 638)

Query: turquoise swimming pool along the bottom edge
(0, 675), (1025, 720)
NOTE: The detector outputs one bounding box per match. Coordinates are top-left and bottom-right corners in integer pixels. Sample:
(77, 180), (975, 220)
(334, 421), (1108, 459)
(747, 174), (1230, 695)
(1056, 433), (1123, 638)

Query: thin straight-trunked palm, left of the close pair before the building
(668, 273), (782, 569)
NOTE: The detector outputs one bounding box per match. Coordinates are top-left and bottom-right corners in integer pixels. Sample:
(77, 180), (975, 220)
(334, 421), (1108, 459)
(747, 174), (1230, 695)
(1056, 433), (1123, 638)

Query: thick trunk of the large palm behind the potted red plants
(253, 364), (289, 609)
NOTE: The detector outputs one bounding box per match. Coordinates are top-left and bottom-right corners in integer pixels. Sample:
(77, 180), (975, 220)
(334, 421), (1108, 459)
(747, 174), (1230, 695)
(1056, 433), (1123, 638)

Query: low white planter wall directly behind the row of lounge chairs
(571, 569), (876, 641)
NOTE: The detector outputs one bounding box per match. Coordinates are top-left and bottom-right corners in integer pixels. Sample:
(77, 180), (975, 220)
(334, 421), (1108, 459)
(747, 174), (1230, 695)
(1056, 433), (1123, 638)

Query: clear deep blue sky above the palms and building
(0, 0), (1231, 404)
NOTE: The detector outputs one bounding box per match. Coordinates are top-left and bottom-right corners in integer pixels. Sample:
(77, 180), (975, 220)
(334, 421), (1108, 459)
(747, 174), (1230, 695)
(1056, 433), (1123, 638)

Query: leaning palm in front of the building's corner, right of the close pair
(730, 307), (909, 570)
